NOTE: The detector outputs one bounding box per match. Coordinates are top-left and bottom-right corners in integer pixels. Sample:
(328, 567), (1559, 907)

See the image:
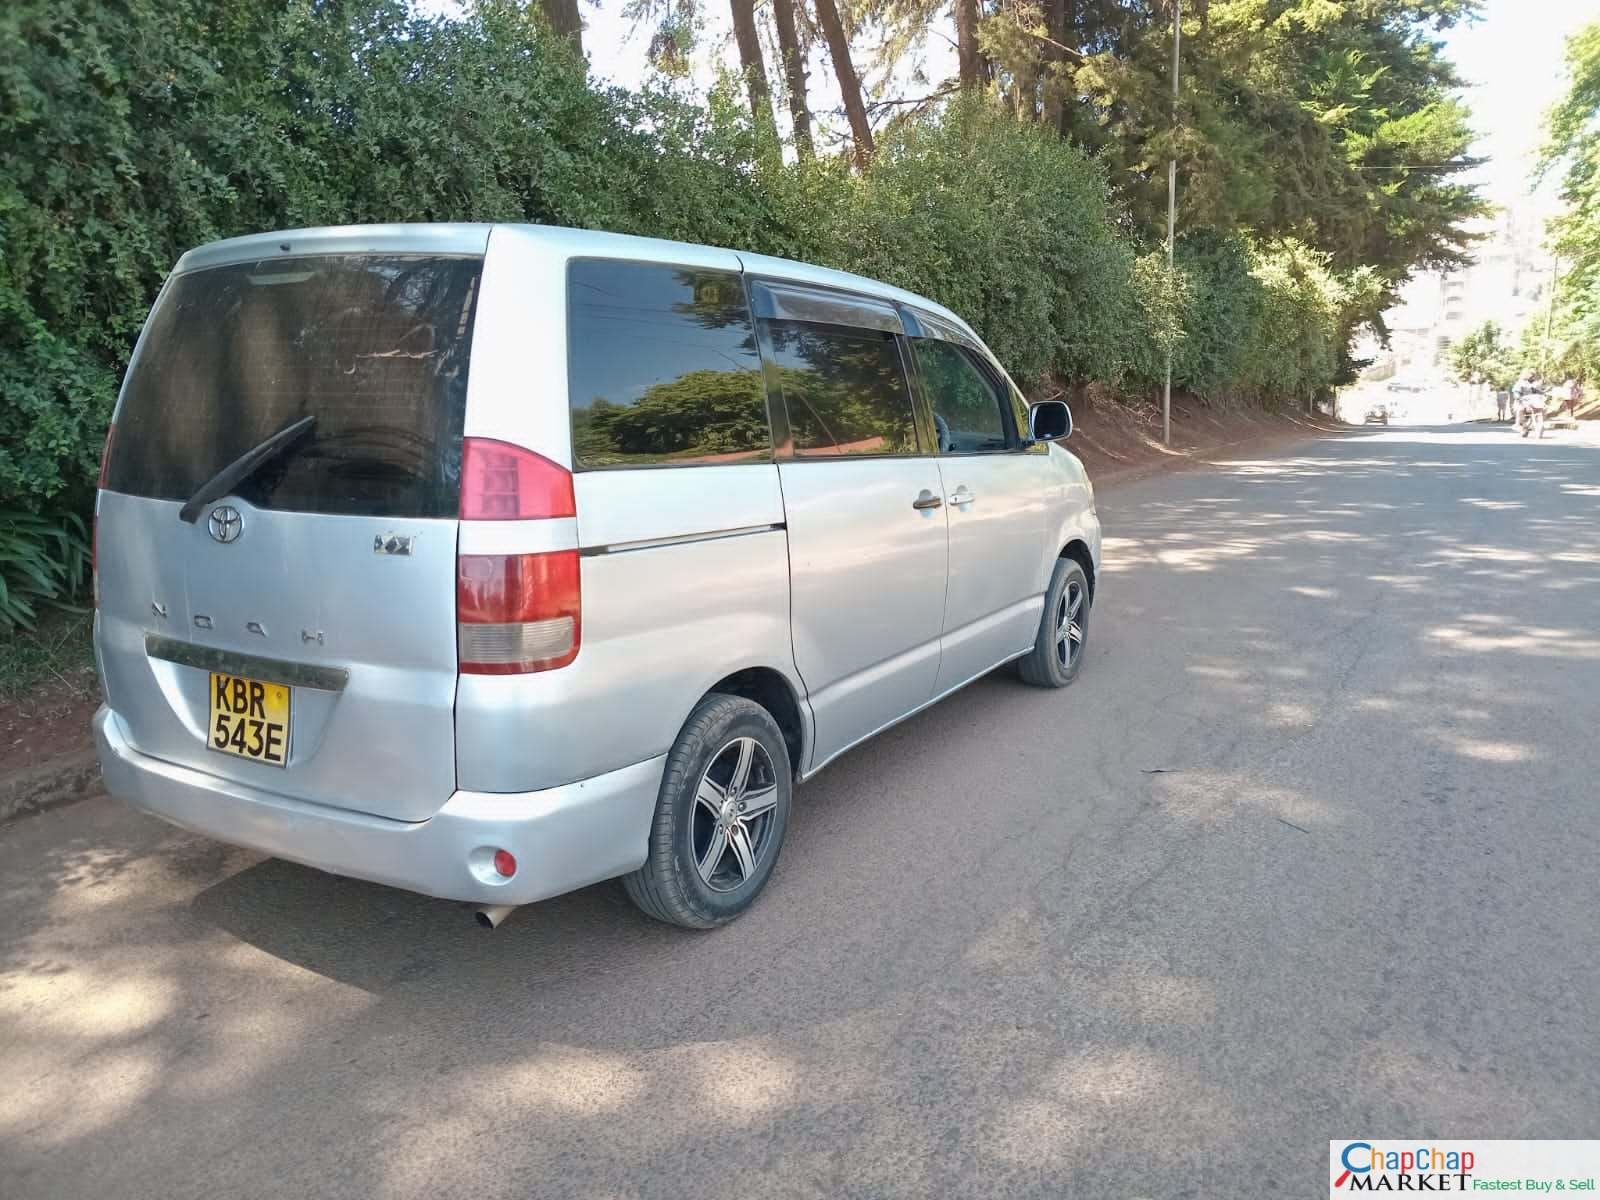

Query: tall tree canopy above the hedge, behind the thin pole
(880, 0), (1485, 315)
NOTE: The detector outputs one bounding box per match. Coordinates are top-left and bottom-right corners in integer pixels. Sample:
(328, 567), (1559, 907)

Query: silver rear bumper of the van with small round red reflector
(94, 709), (666, 904)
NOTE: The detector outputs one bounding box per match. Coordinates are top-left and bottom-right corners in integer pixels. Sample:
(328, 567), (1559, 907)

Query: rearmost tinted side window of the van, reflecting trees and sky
(566, 259), (773, 467)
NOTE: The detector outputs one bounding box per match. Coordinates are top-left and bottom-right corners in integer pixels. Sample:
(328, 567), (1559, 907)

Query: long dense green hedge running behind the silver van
(0, 0), (1349, 620)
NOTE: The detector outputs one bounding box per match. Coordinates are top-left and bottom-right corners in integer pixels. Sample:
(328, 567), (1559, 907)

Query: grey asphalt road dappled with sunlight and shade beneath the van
(0, 426), (1600, 1200)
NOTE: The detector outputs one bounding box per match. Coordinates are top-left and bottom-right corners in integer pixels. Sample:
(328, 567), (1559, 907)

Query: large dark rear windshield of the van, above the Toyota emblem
(107, 254), (483, 517)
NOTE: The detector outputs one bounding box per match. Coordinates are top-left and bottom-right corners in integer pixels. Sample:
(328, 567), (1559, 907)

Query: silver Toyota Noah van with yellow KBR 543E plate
(94, 226), (1101, 928)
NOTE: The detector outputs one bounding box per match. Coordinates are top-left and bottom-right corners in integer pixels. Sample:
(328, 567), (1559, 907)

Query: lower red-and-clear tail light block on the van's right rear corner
(456, 550), (582, 675)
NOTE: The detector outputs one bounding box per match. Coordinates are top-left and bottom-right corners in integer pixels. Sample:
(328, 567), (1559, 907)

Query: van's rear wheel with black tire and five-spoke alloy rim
(622, 691), (794, 930)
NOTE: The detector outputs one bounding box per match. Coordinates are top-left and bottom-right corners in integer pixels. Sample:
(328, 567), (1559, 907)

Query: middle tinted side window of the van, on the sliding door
(762, 320), (918, 458)
